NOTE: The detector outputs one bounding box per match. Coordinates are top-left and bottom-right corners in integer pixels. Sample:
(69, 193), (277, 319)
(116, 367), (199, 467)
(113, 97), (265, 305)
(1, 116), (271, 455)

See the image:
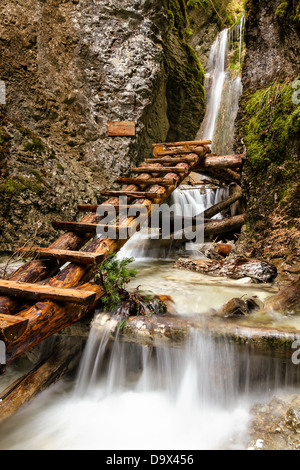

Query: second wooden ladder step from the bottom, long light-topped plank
(0, 280), (96, 306)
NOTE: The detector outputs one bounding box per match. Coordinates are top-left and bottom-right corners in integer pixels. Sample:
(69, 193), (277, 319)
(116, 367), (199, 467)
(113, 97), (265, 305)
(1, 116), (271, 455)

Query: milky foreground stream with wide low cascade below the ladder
(0, 260), (295, 450)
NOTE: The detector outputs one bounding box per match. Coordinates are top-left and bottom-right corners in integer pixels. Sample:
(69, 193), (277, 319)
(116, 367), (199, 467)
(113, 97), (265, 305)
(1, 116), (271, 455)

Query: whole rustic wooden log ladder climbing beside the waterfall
(0, 141), (211, 363)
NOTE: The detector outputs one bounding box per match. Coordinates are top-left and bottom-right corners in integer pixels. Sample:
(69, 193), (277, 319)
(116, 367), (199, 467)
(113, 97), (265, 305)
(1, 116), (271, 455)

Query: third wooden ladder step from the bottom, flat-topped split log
(18, 247), (103, 265)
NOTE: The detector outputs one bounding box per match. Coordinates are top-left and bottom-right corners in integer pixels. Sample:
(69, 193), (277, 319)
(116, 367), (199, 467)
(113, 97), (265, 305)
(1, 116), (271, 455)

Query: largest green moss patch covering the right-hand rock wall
(241, 80), (300, 212)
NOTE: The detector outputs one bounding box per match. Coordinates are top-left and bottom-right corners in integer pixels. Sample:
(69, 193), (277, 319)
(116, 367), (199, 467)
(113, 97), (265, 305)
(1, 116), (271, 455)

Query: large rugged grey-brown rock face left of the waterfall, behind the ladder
(0, 0), (204, 250)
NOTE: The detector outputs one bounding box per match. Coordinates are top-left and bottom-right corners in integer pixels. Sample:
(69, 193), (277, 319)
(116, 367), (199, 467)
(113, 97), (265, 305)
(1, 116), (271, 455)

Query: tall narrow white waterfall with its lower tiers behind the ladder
(119, 15), (244, 258)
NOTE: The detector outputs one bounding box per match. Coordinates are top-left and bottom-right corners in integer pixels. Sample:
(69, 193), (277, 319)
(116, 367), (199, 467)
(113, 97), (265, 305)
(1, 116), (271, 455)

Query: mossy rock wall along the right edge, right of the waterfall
(236, 0), (300, 281)
